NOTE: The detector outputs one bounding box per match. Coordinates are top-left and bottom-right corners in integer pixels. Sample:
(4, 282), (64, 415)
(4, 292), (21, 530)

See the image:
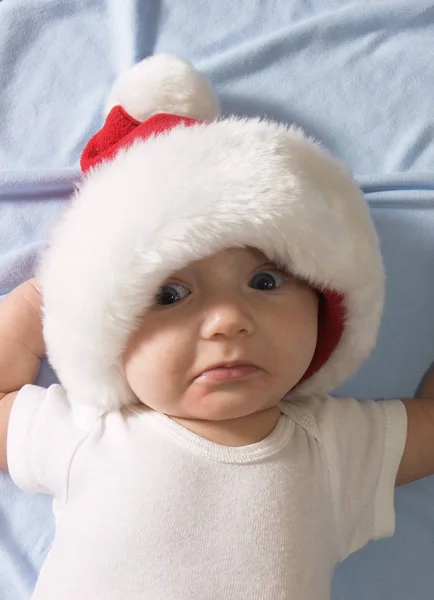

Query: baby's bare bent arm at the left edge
(0, 279), (45, 471)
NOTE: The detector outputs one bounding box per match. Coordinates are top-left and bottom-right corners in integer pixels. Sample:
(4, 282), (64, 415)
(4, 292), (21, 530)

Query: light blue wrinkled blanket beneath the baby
(0, 0), (434, 600)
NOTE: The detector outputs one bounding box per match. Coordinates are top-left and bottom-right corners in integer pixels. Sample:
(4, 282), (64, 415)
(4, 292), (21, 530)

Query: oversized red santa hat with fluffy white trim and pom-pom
(39, 55), (384, 412)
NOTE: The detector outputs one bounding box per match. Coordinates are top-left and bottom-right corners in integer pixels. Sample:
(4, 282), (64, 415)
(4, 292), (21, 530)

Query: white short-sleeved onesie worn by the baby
(8, 385), (407, 600)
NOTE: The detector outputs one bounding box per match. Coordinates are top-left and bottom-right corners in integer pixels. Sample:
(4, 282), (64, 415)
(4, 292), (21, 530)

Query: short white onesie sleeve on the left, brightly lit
(7, 385), (86, 500)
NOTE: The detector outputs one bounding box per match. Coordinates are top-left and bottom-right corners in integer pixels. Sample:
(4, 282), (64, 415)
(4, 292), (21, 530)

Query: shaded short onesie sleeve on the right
(298, 396), (407, 560)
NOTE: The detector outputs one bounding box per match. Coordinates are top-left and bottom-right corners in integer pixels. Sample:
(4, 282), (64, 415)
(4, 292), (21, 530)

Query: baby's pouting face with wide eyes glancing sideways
(124, 248), (318, 420)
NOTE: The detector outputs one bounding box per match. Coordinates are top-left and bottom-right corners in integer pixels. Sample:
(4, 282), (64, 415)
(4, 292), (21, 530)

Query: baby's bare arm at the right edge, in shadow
(396, 365), (434, 485)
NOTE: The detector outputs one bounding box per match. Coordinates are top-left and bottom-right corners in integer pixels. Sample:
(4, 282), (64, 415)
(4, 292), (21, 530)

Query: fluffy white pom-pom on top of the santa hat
(106, 54), (220, 121)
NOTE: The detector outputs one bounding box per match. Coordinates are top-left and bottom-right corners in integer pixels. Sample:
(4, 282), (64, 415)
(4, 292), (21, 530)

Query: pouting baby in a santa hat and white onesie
(0, 56), (434, 600)
